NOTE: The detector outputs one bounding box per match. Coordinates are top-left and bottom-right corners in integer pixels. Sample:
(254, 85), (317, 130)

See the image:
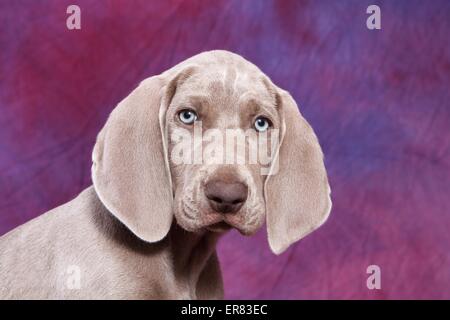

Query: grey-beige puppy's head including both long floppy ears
(93, 51), (331, 253)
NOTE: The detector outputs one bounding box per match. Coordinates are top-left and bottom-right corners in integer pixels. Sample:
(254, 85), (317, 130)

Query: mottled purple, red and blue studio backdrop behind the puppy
(0, 0), (450, 299)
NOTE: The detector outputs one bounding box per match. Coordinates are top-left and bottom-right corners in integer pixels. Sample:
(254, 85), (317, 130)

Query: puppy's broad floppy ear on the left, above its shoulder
(92, 76), (180, 242)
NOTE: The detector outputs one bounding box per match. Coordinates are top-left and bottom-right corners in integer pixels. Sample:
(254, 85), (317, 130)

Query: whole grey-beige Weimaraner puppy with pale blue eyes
(0, 51), (331, 299)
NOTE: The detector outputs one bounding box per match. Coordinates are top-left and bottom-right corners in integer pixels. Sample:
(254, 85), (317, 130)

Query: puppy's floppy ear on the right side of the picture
(264, 90), (331, 254)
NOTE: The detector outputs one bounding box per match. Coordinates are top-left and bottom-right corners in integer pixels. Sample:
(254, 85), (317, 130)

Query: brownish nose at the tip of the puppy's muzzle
(205, 180), (248, 213)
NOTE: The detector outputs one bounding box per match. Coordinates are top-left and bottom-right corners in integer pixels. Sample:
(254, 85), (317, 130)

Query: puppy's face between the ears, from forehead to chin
(165, 66), (280, 235)
